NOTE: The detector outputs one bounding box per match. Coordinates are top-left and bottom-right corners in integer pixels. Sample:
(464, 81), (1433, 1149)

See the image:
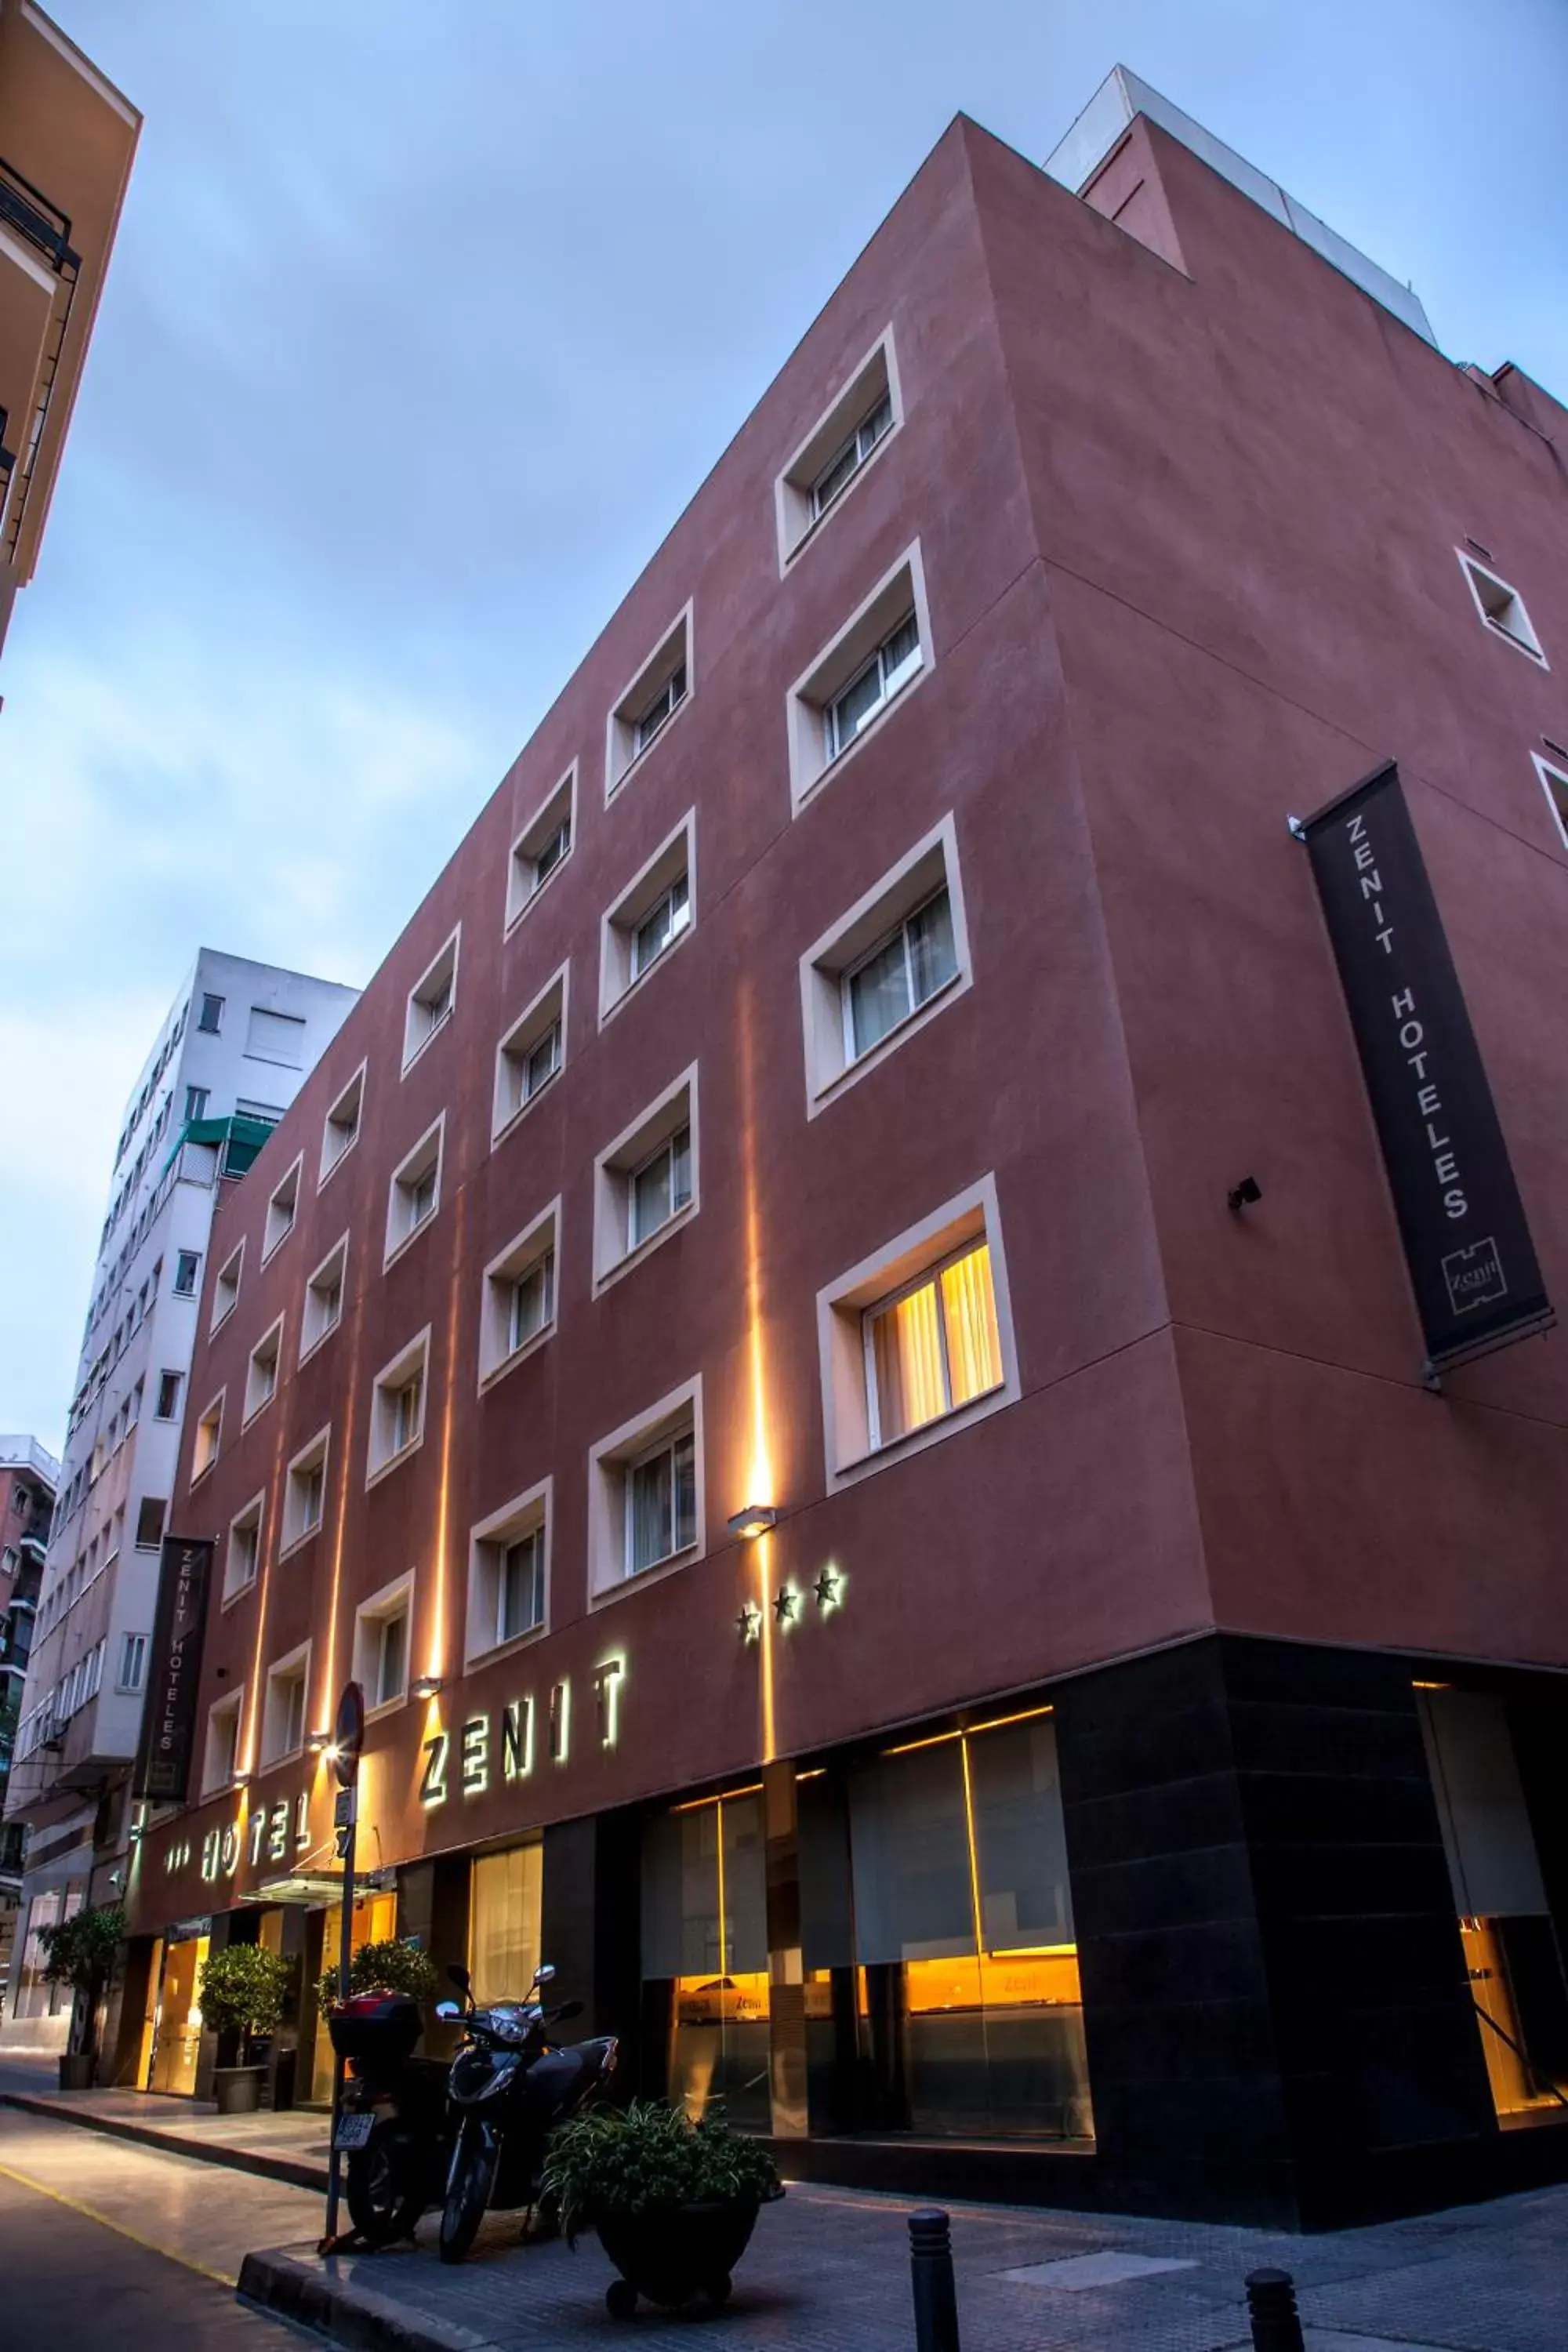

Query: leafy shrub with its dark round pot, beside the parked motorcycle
(541, 2098), (783, 2319)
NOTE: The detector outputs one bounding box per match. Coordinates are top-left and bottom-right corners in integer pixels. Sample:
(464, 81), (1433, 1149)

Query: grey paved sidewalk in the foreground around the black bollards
(240, 2185), (1568, 2352)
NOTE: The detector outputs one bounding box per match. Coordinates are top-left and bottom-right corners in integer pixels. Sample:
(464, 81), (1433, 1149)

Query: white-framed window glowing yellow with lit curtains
(815, 1176), (1018, 1491)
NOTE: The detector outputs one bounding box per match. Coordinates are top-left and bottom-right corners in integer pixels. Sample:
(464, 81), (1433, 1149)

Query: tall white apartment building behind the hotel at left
(0, 948), (358, 2049)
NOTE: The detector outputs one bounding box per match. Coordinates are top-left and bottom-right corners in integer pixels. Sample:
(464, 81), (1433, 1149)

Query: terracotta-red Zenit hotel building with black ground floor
(113, 71), (1568, 2227)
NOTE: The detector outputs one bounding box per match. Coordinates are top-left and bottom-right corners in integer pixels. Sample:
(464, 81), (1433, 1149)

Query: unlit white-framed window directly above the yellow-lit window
(799, 816), (973, 1117)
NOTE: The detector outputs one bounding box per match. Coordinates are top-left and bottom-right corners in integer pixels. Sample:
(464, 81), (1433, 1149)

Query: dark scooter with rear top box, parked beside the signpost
(327, 1992), (452, 2246)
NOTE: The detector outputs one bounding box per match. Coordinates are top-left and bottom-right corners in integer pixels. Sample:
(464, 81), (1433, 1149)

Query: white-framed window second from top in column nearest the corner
(787, 541), (931, 809)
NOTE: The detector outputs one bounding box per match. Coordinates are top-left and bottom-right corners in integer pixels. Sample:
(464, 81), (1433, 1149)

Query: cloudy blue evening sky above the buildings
(0, 0), (1568, 1446)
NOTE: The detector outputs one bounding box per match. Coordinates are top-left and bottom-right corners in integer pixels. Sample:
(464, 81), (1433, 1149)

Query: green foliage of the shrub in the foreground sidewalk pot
(541, 2098), (779, 2244)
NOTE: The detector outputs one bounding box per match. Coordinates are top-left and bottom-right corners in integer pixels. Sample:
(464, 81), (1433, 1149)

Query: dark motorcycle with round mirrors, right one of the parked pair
(435, 1962), (616, 2263)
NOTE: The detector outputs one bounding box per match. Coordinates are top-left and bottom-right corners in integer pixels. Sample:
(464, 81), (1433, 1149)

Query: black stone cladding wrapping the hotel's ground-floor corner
(1055, 1635), (1568, 2230)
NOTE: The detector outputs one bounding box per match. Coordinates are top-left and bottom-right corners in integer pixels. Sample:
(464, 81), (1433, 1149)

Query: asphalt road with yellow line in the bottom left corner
(0, 2107), (322, 2352)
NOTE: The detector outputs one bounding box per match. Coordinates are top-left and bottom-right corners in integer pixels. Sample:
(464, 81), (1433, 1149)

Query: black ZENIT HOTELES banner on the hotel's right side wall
(1298, 760), (1554, 1376)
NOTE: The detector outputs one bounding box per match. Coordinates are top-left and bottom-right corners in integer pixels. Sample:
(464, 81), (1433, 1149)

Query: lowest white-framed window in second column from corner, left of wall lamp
(588, 1378), (708, 1602)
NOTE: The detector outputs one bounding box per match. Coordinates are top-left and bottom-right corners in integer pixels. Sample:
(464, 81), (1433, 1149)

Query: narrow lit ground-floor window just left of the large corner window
(642, 1790), (771, 2131)
